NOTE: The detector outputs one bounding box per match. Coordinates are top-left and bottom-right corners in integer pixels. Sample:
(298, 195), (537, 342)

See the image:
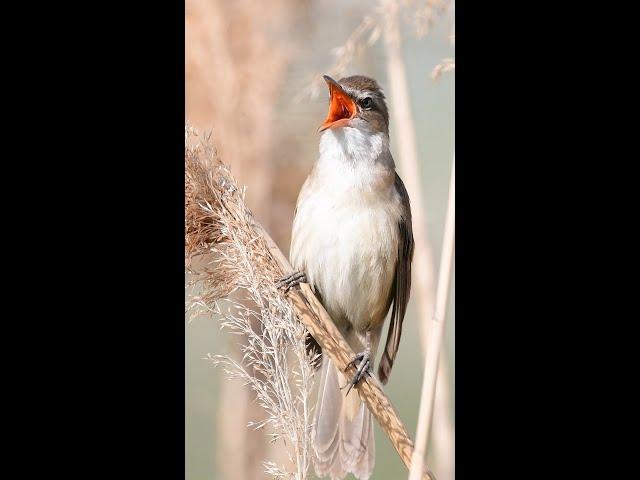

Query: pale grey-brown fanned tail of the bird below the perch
(313, 355), (375, 480)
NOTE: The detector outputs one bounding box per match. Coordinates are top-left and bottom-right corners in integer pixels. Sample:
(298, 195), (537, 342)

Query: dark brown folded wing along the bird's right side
(378, 173), (413, 384)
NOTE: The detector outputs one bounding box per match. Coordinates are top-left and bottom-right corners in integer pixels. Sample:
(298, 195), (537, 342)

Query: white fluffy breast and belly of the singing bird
(291, 128), (401, 336)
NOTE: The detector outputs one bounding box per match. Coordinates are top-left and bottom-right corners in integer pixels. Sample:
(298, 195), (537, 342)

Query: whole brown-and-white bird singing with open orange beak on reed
(281, 75), (413, 480)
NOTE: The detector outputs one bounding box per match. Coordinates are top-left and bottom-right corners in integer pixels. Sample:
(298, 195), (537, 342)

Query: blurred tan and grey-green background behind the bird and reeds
(185, 0), (455, 480)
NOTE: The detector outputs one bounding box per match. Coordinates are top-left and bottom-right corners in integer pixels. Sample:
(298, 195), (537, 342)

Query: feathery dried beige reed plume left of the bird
(185, 126), (315, 479)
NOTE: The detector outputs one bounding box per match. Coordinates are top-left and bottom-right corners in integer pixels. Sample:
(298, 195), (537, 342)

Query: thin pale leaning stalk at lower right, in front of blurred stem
(409, 158), (455, 480)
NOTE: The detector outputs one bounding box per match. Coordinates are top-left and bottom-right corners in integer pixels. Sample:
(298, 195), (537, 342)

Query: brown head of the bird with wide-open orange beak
(318, 75), (389, 136)
